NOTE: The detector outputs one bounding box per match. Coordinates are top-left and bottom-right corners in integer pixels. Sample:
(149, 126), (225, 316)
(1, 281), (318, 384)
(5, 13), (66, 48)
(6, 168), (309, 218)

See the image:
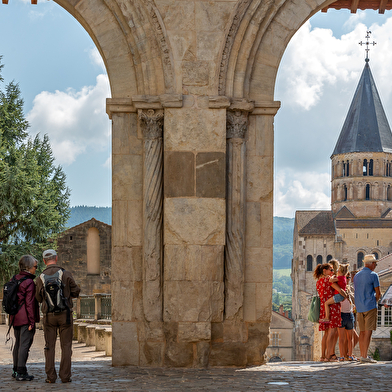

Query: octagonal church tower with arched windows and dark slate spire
(331, 56), (392, 218)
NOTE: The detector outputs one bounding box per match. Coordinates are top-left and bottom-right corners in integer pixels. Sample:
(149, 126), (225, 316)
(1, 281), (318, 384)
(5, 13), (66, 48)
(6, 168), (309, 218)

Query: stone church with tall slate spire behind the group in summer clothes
(292, 58), (392, 360)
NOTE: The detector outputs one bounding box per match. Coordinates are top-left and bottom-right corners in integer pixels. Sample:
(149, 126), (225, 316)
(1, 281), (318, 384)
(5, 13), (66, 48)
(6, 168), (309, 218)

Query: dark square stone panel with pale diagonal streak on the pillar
(196, 152), (226, 198)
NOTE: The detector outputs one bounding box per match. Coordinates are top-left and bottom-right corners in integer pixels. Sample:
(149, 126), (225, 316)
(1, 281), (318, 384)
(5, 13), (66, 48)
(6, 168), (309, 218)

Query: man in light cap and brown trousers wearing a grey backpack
(36, 249), (80, 383)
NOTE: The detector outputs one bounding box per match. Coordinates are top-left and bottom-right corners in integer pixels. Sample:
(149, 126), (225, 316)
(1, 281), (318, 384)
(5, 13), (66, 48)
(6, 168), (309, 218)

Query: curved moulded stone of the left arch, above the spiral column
(55, 0), (174, 99)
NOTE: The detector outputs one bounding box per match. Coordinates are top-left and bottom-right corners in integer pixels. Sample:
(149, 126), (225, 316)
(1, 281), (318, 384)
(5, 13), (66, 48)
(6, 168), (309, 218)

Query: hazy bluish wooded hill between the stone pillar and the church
(273, 216), (294, 269)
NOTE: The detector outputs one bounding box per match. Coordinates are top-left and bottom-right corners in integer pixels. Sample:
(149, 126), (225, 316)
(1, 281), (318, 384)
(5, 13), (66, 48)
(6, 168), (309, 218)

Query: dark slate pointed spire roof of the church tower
(332, 62), (392, 156)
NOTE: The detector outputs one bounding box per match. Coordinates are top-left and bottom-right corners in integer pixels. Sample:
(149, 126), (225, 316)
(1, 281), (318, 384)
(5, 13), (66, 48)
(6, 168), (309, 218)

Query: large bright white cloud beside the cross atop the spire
(279, 21), (366, 110)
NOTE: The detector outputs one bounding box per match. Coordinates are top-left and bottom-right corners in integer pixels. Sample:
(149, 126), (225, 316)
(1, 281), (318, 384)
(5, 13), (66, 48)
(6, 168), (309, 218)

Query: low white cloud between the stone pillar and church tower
(274, 170), (331, 218)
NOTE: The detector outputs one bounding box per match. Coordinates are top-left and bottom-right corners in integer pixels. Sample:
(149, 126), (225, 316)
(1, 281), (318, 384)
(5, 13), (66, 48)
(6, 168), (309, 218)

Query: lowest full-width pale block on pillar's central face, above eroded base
(163, 281), (224, 322)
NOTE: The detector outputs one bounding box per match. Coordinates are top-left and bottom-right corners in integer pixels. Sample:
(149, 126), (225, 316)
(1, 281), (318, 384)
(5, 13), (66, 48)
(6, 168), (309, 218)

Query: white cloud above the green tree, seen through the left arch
(27, 75), (110, 164)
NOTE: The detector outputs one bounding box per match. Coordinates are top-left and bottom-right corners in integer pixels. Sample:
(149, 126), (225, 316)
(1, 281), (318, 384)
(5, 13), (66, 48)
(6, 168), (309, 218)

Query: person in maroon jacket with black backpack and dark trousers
(3, 255), (39, 381)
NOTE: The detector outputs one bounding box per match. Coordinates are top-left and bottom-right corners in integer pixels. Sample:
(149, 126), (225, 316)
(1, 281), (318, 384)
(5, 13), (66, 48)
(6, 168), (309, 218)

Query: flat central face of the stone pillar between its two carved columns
(163, 95), (229, 367)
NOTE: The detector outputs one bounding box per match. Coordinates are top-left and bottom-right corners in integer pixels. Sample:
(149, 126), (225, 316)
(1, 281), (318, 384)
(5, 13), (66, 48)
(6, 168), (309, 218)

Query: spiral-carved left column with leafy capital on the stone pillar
(138, 109), (163, 321)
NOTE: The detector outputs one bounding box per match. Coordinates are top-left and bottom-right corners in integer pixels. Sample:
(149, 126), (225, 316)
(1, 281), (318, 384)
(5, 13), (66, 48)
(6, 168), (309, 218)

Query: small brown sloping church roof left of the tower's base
(295, 211), (335, 236)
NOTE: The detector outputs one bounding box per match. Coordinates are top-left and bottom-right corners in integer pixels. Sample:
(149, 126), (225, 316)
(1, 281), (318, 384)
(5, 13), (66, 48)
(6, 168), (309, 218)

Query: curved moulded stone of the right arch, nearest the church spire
(218, 0), (330, 101)
